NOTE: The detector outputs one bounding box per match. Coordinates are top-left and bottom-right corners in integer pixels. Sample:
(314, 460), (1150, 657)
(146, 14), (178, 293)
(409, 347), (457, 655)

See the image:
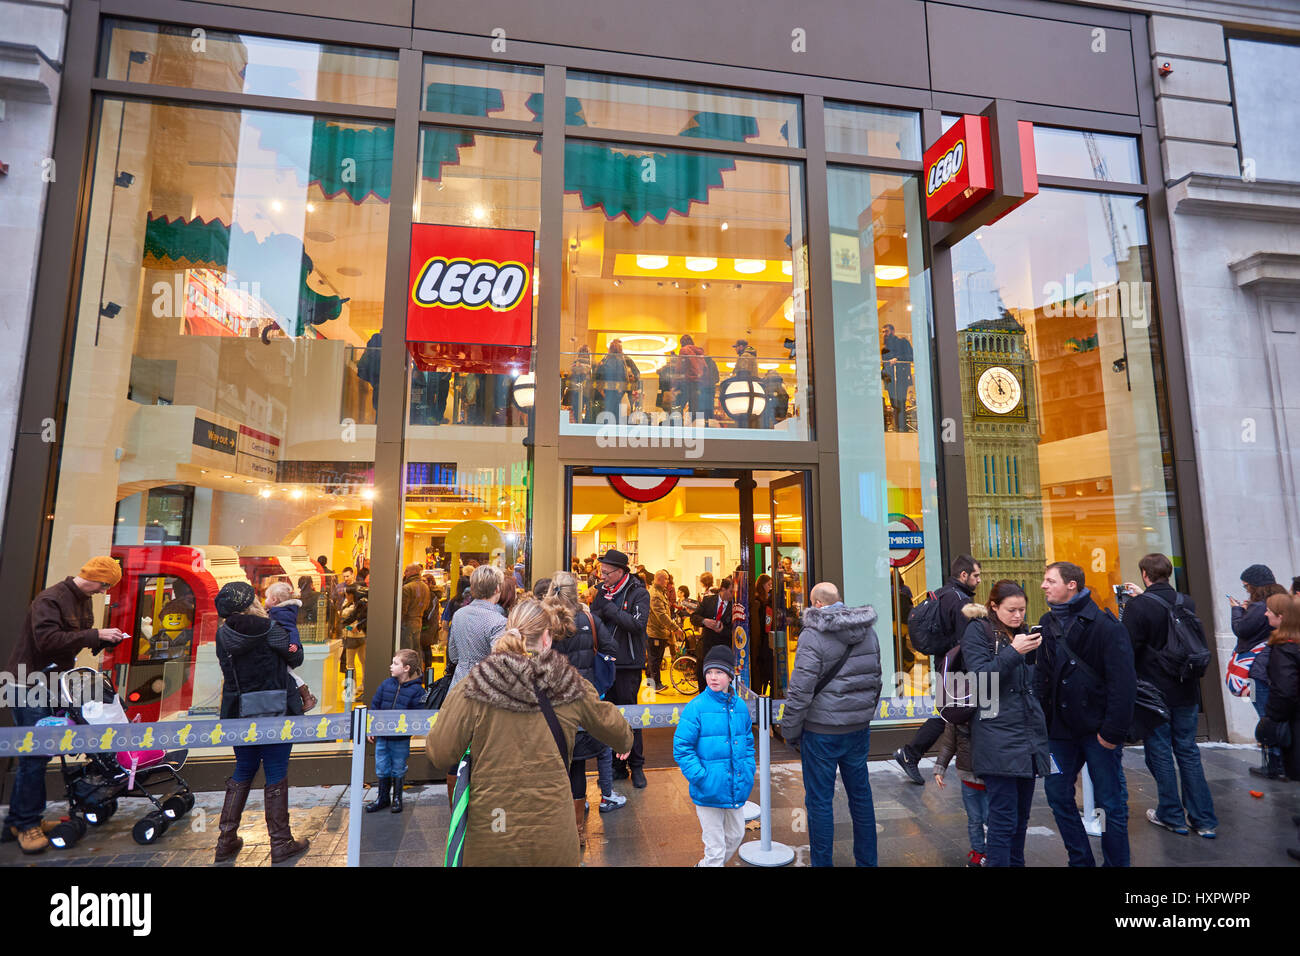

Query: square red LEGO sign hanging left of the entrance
(407, 222), (534, 375)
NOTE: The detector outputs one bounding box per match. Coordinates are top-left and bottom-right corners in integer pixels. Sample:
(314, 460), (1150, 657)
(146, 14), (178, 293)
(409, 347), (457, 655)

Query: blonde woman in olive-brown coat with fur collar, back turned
(425, 598), (632, 866)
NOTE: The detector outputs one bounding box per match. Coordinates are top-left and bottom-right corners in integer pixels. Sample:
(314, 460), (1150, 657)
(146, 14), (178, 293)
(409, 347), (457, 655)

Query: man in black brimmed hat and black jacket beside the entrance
(592, 548), (650, 790)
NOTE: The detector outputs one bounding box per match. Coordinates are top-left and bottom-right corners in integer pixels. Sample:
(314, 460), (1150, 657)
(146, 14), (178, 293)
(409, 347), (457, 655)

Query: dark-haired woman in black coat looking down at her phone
(961, 580), (1052, 866)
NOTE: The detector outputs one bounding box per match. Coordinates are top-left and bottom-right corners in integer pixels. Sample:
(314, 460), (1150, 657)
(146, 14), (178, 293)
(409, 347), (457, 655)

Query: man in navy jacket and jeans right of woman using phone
(1034, 561), (1138, 866)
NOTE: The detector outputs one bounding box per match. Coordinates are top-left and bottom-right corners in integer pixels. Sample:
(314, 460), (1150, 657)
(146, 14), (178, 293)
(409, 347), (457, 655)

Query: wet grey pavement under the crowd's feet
(0, 744), (1300, 868)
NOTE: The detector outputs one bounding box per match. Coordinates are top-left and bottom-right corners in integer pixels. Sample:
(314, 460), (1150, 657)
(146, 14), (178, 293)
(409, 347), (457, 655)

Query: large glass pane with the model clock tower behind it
(953, 189), (1182, 619)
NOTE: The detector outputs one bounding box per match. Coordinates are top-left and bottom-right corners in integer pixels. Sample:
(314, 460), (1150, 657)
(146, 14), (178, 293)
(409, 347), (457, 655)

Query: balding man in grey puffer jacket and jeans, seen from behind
(781, 583), (880, 866)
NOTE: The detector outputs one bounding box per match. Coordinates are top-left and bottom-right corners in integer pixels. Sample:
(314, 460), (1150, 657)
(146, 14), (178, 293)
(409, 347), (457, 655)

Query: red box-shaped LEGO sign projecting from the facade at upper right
(922, 114), (1039, 224)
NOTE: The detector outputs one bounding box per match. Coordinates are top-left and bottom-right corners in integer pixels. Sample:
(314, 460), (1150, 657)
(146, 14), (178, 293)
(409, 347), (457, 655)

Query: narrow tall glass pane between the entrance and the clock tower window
(827, 166), (943, 719)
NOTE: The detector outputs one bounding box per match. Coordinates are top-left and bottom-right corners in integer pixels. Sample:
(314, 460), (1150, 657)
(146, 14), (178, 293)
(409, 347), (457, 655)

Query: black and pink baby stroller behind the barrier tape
(40, 667), (194, 849)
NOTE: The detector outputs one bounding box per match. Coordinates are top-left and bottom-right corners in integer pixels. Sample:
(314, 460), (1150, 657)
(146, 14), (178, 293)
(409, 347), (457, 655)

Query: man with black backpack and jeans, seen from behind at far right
(1123, 554), (1218, 840)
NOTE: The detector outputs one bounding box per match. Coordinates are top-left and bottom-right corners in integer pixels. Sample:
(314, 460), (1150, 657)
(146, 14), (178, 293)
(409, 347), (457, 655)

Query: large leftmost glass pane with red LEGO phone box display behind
(47, 99), (393, 719)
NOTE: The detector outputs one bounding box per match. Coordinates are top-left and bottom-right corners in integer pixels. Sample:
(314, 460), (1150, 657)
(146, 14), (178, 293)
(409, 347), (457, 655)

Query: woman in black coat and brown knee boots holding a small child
(215, 581), (309, 864)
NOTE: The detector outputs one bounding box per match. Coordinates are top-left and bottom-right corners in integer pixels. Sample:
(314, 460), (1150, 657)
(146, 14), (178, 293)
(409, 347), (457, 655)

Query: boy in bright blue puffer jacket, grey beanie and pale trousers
(672, 646), (757, 866)
